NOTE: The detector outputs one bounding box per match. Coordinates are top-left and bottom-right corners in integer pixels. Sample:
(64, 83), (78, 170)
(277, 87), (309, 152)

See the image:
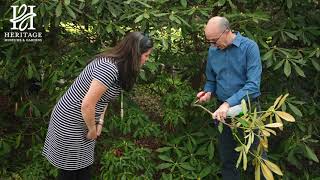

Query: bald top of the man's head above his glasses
(205, 16), (230, 33)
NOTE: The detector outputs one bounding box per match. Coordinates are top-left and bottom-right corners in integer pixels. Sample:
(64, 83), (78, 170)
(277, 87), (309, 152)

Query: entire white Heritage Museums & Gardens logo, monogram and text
(4, 4), (42, 42)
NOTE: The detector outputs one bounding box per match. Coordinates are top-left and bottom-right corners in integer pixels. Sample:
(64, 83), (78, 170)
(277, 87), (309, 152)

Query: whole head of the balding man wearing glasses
(204, 16), (233, 49)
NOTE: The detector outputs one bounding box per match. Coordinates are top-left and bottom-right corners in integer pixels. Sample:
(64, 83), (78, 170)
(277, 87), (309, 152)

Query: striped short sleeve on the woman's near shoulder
(92, 62), (118, 87)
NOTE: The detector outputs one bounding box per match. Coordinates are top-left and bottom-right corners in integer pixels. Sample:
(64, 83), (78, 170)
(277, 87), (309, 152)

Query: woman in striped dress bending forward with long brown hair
(43, 32), (153, 180)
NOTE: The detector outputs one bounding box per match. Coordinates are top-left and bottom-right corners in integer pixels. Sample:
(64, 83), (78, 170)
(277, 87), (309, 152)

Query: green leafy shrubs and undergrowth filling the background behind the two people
(0, 0), (320, 179)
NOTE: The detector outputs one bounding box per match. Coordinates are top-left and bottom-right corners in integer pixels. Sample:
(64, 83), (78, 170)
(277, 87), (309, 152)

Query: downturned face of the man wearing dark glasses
(205, 25), (229, 49)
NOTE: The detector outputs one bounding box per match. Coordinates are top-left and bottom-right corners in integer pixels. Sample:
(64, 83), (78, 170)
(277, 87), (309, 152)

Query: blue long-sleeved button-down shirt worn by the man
(204, 32), (262, 106)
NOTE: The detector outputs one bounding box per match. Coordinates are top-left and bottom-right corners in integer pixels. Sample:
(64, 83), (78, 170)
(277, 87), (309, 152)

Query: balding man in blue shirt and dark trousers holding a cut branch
(197, 16), (262, 180)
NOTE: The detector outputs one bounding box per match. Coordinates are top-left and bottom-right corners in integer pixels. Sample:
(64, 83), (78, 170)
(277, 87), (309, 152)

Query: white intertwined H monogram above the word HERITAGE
(10, 4), (37, 31)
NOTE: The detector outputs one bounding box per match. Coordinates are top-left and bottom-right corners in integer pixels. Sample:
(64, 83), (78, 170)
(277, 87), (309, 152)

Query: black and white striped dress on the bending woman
(42, 58), (121, 170)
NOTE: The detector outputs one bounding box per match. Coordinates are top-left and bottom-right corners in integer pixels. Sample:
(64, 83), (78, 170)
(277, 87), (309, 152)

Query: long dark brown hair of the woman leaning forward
(96, 32), (153, 91)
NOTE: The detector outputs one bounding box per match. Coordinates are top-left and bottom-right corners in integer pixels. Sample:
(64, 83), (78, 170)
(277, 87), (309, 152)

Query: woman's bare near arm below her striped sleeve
(81, 79), (107, 139)
